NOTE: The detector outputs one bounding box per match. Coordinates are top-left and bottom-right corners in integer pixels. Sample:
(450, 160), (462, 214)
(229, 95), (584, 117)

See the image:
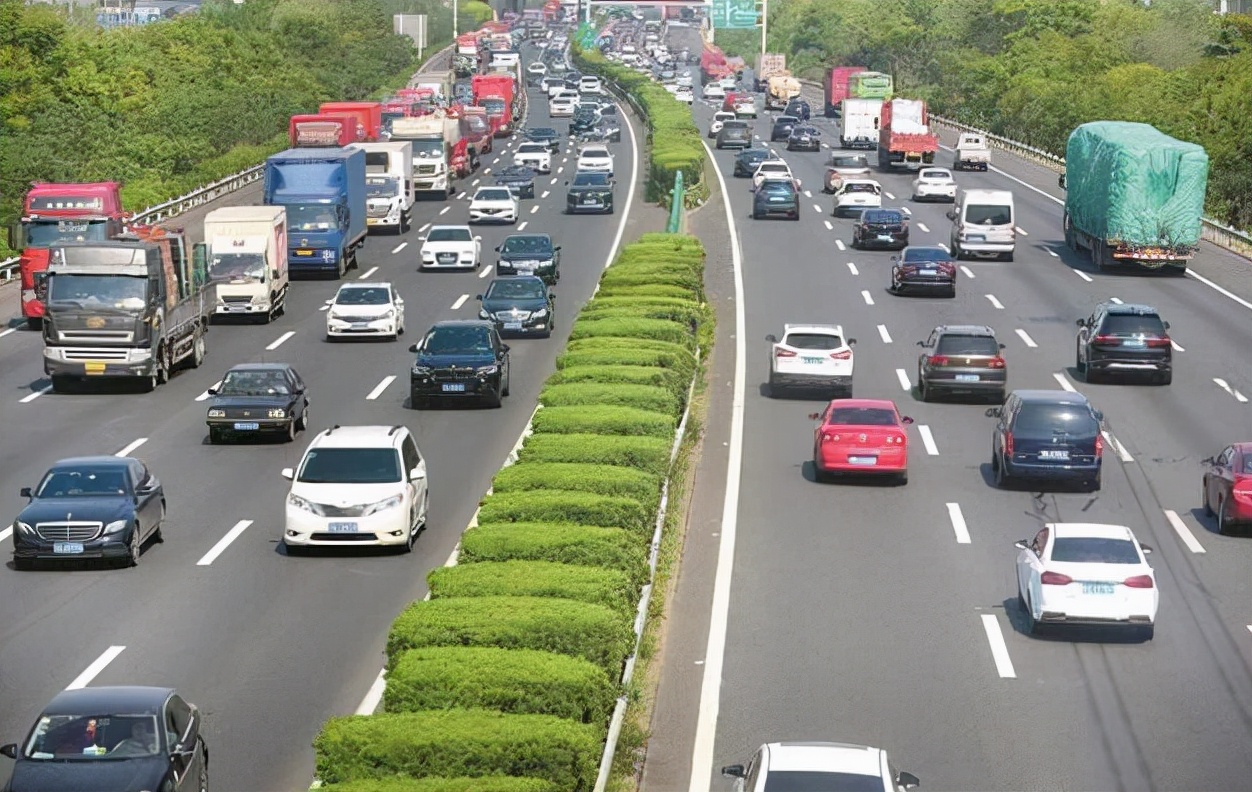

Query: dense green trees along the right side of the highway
(717, 0), (1252, 228)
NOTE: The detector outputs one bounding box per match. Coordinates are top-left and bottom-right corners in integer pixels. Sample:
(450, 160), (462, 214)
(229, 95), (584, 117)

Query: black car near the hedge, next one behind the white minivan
(408, 319), (508, 409)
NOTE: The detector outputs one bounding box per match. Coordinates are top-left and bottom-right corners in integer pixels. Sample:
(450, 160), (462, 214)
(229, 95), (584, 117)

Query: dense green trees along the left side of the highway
(0, 0), (428, 256)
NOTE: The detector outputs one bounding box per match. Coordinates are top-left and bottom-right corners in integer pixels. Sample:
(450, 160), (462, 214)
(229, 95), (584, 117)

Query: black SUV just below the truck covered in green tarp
(1074, 303), (1173, 385)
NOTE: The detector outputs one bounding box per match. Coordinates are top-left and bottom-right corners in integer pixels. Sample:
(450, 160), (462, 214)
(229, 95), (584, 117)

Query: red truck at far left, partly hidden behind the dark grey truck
(9, 181), (128, 330)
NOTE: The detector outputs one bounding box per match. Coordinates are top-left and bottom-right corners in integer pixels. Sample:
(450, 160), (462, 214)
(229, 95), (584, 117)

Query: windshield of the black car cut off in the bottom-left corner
(23, 713), (160, 761)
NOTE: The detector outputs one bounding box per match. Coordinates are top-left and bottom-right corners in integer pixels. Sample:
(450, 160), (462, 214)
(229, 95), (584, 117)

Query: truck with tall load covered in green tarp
(1060, 121), (1208, 274)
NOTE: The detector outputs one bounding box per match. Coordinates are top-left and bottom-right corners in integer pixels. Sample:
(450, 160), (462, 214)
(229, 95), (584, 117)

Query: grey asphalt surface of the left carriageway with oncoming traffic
(0, 44), (642, 791)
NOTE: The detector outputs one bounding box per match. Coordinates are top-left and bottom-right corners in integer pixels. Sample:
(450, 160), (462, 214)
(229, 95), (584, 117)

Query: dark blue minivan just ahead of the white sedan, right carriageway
(987, 390), (1104, 492)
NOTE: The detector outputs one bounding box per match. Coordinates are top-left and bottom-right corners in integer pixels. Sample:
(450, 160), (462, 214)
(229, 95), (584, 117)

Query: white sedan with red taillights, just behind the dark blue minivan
(1014, 523), (1161, 638)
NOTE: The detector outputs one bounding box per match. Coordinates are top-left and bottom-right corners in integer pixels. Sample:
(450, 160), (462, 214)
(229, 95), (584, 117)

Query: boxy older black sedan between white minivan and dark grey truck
(205, 363), (309, 443)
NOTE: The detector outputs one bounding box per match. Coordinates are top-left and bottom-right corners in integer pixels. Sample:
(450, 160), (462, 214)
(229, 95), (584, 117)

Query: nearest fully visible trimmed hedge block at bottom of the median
(313, 709), (603, 792)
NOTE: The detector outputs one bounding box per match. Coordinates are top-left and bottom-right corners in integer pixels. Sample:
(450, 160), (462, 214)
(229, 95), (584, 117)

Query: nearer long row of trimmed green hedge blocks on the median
(316, 234), (711, 792)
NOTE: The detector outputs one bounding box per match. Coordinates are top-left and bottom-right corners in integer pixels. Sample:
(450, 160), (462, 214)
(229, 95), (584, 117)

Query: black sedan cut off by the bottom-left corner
(0, 686), (209, 792)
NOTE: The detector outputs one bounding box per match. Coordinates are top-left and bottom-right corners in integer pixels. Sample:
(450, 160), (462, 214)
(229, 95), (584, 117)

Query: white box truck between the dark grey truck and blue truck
(195, 206), (288, 323)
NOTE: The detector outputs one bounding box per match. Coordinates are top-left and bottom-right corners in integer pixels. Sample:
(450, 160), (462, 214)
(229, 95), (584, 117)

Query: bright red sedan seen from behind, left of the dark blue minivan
(809, 399), (913, 484)
